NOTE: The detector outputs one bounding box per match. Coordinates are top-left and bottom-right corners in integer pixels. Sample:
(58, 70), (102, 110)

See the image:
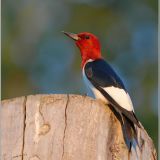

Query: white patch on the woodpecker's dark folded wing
(103, 86), (134, 111)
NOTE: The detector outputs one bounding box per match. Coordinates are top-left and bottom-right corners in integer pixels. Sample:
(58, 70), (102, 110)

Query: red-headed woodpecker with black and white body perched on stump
(62, 31), (141, 151)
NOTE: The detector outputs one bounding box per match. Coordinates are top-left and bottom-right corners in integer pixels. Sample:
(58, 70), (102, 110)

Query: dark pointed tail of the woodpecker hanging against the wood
(121, 115), (138, 152)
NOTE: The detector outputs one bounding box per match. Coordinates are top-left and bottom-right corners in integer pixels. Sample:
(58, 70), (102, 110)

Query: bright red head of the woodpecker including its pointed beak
(63, 32), (102, 67)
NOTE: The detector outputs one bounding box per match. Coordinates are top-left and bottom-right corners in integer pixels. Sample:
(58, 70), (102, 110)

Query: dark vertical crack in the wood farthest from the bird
(21, 96), (27, 160)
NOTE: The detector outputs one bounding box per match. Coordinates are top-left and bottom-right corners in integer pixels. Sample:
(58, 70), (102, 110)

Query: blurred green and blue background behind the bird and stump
(2, 0), (158, 150)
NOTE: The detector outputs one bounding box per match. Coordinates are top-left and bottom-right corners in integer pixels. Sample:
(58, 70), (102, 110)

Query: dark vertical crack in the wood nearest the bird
(61, 94), (69, 160)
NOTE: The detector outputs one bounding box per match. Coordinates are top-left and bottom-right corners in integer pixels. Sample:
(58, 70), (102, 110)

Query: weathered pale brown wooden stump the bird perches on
(0, 95), (157, 160)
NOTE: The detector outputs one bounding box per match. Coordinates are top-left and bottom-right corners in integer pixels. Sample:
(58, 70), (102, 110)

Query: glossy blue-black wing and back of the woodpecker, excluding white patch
(84, 59), (140, 127)
